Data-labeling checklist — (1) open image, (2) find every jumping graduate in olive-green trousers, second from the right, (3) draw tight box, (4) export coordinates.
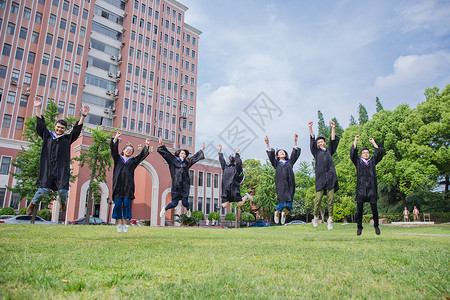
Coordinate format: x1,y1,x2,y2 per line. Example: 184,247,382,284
308,121,339,230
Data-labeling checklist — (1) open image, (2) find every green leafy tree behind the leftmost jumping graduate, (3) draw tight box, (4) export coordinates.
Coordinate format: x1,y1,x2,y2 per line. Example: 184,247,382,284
7,101,77,223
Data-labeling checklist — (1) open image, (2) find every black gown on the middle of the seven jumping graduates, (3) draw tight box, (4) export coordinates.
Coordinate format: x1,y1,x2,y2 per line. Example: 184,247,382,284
219,153,243,202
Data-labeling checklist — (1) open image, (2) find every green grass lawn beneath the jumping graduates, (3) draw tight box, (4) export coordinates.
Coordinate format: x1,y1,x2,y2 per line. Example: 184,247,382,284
0,224,450,299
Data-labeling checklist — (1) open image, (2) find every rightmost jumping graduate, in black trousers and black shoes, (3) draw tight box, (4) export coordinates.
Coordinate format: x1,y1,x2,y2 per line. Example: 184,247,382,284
350,135,383,235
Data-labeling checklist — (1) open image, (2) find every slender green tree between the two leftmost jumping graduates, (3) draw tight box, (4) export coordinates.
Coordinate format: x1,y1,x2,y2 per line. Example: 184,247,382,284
74,125,114,225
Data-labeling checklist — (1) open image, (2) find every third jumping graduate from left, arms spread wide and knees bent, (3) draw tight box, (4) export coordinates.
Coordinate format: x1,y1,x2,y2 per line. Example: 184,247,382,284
158,137,205,218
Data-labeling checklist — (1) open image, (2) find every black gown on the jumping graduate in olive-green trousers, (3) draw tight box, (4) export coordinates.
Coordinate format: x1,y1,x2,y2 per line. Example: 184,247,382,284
309,136,339,192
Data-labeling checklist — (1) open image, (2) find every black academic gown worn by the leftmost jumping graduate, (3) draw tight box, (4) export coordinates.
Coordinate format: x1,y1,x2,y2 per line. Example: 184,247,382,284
36,116,83,191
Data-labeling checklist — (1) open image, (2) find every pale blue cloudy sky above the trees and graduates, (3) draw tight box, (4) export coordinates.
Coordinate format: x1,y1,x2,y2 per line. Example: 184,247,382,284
181,0,450,160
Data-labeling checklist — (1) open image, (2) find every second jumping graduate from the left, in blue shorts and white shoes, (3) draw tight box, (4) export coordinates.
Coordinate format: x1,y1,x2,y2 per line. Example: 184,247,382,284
110,131,150,233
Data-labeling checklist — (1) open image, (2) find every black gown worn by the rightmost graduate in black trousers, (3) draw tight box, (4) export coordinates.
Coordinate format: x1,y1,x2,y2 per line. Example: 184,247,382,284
350,145,383,203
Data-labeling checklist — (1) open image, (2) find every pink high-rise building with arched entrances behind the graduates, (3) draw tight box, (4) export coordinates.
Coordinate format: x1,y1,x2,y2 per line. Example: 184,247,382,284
0,0,224,225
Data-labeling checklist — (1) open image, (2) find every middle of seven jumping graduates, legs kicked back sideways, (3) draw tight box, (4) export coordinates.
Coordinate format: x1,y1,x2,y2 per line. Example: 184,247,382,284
217,145,253,208
